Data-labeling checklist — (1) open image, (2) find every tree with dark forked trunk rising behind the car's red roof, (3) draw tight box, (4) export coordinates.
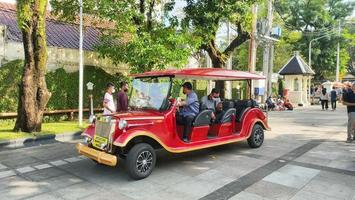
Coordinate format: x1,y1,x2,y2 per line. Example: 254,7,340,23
184,0,256,96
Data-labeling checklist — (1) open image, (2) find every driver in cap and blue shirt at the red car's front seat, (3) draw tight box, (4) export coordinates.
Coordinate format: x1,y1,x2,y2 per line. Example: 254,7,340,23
176,82,200,142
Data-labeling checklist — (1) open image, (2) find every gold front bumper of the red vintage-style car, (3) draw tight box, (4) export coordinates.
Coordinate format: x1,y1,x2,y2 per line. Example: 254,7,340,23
76,143,117,166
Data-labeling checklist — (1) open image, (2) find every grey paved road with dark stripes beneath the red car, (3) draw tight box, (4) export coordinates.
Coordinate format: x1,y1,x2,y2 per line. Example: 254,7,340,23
0,107,355,200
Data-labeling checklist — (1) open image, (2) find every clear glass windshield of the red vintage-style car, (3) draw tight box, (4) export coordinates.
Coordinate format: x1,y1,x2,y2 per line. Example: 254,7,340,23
129,77,171,110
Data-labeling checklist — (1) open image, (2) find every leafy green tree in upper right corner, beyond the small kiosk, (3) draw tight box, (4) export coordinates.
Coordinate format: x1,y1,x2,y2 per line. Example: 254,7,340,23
274,0,355,80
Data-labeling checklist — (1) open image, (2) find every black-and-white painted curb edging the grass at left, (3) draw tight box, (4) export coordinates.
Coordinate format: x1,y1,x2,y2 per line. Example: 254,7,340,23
0,131,83,151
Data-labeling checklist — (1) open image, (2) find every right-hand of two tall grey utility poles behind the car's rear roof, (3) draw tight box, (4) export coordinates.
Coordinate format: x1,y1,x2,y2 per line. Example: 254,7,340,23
263,0,273,101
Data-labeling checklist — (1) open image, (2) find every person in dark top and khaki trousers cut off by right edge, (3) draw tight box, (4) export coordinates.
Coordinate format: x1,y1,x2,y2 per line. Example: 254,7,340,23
342,82,355,143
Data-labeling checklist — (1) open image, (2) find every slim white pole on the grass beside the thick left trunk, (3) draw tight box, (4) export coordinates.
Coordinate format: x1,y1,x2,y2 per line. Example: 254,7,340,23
79,0,84,126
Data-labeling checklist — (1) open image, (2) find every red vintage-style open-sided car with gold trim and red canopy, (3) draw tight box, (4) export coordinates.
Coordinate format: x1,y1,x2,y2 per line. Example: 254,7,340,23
77,68,269,179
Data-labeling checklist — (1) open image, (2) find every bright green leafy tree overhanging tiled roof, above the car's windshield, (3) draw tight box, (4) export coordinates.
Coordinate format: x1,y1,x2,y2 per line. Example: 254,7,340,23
51,0,198,73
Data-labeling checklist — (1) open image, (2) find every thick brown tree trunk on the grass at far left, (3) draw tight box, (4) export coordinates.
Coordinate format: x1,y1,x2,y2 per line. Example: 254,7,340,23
14,0,51,132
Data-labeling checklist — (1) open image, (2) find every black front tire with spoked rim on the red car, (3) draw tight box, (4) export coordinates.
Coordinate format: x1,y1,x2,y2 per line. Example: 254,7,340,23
126,143,156,180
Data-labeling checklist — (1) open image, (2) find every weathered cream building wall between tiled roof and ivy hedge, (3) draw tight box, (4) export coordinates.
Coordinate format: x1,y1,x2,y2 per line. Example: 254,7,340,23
0,25,129,75
